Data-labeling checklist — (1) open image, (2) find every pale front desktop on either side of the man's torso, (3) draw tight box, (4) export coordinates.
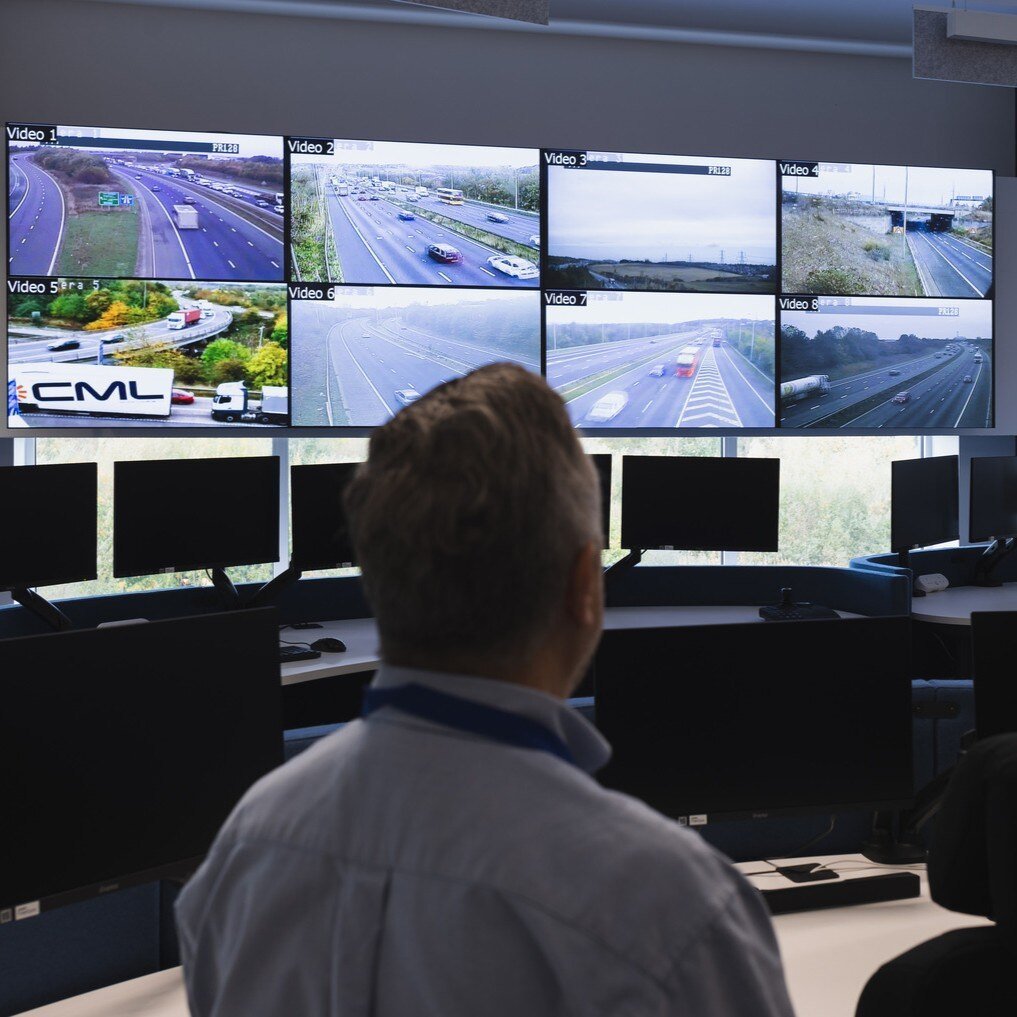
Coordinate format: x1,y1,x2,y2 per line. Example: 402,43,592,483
15,855,972,1017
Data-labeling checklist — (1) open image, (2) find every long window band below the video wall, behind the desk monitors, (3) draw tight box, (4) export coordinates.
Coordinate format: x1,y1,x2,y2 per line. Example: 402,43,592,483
15,435,959,599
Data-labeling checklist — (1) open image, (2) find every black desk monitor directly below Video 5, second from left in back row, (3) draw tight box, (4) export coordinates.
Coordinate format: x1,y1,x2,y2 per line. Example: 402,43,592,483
113,456,280,577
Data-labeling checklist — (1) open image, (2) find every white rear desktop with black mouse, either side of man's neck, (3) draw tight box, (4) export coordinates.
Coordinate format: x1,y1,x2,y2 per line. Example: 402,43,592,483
280,604,859,685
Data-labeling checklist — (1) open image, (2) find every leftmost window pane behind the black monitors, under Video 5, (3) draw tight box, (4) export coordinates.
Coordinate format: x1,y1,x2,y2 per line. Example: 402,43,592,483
28,436,273,600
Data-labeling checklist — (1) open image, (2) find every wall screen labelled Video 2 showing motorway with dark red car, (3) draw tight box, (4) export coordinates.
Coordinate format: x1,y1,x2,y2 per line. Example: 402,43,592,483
286,137,540,288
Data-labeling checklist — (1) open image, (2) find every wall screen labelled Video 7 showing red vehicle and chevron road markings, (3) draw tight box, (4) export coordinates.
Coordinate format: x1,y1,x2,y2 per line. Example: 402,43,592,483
544,290,774,429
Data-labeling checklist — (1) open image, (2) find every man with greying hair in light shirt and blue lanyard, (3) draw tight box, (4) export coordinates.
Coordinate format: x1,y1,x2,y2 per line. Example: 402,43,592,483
177,364,791,1017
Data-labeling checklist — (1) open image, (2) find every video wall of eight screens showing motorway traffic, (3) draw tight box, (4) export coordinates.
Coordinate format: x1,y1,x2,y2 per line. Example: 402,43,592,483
5,124,994,434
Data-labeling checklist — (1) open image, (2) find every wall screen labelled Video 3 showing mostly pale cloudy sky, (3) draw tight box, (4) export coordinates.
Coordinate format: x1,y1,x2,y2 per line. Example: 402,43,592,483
542,151,777,294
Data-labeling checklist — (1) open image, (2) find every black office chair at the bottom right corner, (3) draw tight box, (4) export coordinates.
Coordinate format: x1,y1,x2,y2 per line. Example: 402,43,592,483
855,734,1017,1017
